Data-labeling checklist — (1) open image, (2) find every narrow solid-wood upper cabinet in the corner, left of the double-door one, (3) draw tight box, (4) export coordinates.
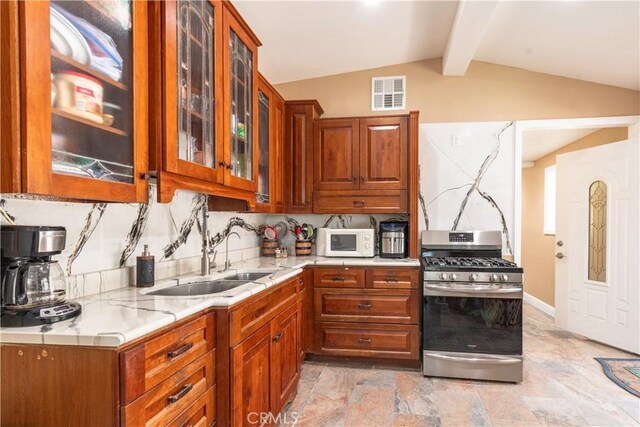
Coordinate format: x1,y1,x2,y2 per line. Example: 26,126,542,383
284,100,324,214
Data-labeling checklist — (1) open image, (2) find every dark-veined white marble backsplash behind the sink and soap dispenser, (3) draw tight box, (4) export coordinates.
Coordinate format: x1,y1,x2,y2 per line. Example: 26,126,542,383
2,186,266,297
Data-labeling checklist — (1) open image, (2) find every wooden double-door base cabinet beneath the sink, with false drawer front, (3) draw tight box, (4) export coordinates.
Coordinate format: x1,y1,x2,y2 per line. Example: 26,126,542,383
228,277,302,425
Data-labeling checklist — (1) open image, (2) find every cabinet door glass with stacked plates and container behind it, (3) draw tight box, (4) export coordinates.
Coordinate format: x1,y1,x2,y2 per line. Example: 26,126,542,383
49,0,134,183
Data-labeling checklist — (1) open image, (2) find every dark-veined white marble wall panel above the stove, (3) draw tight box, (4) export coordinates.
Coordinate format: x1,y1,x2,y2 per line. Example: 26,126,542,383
419,122,515,255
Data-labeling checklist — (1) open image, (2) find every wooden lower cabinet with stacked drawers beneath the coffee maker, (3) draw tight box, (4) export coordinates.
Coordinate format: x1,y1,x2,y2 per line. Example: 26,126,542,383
0,312,218,426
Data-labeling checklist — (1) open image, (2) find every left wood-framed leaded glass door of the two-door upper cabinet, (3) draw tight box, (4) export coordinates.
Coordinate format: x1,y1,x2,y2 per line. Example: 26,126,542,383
151,0,225,189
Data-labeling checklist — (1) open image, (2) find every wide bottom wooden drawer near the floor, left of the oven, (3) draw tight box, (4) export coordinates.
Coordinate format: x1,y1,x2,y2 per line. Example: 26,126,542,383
315,322,420,360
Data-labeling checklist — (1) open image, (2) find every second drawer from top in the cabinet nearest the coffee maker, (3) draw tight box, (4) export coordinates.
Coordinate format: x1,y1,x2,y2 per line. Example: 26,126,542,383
122,351,215,426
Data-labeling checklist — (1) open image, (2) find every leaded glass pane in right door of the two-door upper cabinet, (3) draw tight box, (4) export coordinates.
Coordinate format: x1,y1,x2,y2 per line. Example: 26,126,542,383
229,30,253,181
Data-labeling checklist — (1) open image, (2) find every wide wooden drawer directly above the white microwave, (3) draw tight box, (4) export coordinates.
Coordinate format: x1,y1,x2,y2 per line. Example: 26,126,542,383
313,190,407,214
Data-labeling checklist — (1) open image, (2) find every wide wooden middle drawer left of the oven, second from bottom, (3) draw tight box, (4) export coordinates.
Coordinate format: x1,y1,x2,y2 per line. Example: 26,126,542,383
314,288,421,324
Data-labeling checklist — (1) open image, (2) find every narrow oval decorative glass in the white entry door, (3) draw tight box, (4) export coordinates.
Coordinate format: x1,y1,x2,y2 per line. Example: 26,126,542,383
587,181,607,282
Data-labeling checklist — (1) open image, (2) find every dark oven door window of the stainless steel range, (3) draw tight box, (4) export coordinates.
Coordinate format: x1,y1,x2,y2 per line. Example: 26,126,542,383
423,296,522,354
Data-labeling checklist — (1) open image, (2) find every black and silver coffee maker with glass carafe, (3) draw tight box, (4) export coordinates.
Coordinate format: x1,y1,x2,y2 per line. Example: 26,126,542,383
0,225,82,327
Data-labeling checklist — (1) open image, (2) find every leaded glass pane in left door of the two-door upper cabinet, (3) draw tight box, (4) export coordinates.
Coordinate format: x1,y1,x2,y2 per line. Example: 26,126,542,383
177,1,216,168
